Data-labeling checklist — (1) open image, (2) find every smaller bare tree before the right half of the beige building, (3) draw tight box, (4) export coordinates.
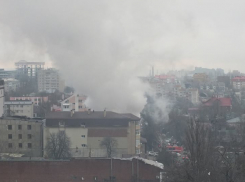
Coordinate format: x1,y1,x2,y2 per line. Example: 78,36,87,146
100,137,117,158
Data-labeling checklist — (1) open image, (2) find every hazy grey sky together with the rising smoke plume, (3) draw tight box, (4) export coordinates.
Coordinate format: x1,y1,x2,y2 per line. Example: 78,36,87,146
0,0,245,111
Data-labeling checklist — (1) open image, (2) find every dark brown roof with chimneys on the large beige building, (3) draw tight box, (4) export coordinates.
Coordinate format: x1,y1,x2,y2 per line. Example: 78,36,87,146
46,111,140,121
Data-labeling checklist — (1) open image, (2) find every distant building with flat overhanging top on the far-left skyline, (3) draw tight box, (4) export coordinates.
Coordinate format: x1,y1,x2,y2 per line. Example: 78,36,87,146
15,60,45,78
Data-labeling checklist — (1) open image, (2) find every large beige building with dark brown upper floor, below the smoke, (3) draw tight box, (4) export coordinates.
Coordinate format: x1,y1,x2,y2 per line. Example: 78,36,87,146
44,110,140,157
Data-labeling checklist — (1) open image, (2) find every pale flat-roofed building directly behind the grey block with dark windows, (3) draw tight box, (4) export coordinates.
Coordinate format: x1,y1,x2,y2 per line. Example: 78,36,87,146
4,101,34,118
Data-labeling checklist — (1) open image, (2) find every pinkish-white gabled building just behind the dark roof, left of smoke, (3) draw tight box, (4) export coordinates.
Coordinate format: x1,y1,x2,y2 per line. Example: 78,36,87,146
61,94,87,111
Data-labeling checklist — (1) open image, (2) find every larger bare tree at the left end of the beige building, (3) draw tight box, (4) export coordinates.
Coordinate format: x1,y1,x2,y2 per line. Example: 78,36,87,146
45,131,71,159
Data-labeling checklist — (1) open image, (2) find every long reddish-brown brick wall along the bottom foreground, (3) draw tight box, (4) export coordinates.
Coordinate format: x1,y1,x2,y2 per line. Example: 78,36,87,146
0,159,161,182
